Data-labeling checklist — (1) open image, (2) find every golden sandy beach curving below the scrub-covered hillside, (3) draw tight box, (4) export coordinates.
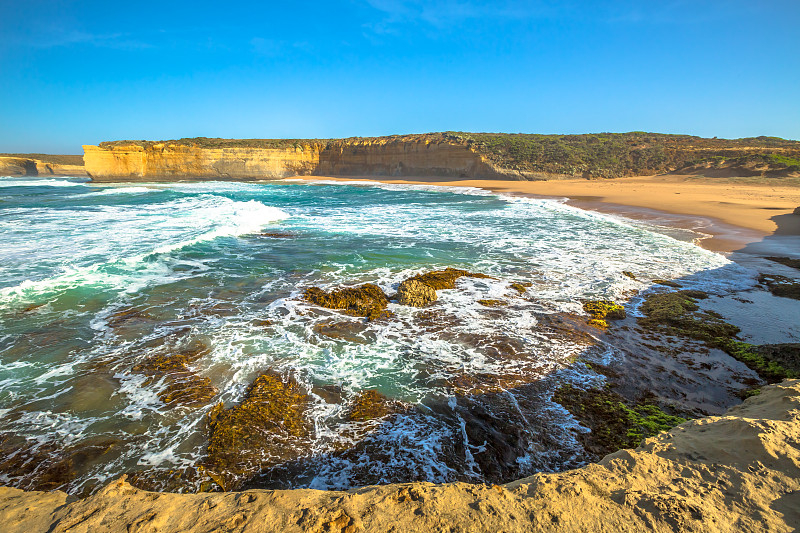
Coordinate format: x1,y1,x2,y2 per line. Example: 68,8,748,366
303,174,800,252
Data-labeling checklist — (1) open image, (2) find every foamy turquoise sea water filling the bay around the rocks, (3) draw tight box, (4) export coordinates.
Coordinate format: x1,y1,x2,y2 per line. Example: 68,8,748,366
0,178,753,492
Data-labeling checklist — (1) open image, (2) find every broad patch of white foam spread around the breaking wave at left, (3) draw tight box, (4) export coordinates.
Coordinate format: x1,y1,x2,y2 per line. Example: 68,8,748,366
0,195,289,301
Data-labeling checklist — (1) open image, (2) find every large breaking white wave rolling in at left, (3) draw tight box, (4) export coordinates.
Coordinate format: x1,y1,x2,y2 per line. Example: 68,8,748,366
0,195,289,301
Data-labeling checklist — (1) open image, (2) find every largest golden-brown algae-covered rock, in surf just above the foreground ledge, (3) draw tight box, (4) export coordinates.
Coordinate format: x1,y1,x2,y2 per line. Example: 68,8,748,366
203,372,313,490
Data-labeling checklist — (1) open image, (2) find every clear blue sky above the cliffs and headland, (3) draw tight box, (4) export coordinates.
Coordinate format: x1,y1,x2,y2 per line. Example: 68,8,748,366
0,0,800,153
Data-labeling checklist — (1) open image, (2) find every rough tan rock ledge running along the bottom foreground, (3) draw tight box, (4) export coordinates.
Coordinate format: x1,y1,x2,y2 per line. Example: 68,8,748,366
0,380,800,533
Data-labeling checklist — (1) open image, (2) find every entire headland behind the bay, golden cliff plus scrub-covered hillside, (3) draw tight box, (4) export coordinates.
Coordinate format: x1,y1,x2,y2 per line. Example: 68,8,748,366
84,132,800,180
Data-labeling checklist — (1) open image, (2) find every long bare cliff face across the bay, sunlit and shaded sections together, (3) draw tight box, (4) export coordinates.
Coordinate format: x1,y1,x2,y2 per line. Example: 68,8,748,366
83,137,552,181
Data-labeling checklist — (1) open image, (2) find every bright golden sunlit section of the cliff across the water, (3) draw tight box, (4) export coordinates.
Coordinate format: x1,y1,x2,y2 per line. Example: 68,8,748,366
83,143,319,181
